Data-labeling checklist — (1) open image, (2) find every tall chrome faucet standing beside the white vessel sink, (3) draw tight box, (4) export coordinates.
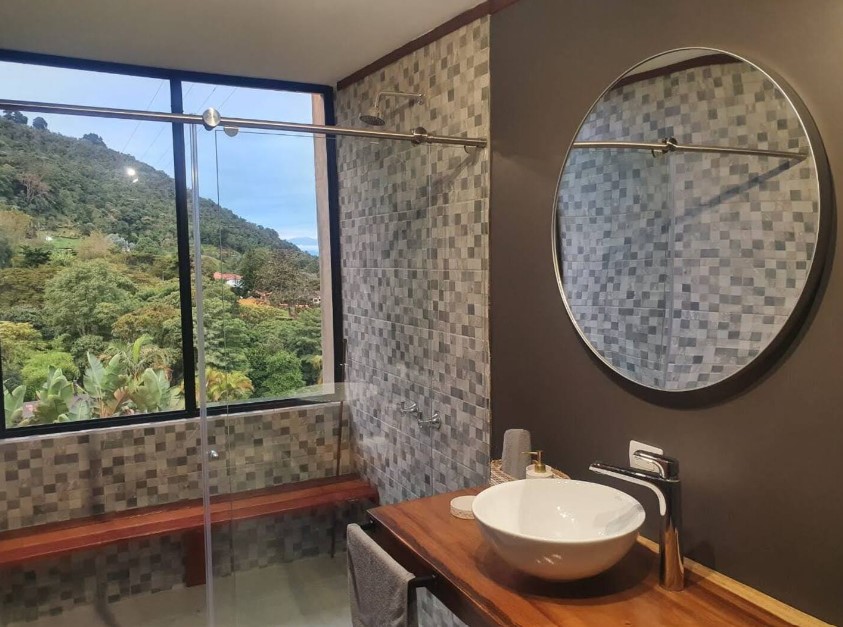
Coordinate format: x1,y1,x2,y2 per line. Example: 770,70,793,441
588,451,685,591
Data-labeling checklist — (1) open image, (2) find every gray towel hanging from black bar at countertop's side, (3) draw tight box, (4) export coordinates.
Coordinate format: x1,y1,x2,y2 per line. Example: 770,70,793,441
346,524,418,627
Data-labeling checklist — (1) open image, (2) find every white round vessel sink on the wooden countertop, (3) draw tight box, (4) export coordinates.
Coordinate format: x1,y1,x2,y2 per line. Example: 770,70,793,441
472,479,644,581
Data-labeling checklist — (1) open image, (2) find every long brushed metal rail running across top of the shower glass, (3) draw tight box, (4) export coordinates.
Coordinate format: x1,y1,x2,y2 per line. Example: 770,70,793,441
0,100,487,148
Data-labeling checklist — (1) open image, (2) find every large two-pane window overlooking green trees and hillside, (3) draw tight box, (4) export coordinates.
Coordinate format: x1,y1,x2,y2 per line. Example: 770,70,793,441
0,56,335,435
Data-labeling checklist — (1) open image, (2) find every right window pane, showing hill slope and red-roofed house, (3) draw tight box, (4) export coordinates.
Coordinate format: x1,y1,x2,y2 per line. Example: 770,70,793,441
186,86,328,405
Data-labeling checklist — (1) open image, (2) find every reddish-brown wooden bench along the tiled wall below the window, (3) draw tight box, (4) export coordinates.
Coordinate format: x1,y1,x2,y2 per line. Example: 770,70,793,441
0,475,379,586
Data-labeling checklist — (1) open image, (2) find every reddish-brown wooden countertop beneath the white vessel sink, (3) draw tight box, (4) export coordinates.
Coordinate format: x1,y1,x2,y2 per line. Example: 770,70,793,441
369,489,823,627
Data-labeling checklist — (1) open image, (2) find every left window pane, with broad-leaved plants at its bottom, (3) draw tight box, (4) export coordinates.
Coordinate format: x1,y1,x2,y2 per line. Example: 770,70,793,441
0,64,184,428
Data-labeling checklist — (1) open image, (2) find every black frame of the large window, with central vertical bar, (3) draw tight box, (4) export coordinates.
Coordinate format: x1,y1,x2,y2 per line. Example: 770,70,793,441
0,49,345,441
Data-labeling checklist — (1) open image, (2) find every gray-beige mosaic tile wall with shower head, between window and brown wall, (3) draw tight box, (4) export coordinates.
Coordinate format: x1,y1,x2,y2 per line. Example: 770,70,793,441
337,18,489,625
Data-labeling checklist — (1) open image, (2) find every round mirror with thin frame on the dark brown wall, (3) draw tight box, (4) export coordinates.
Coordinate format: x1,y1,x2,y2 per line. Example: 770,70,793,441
554,48,829,392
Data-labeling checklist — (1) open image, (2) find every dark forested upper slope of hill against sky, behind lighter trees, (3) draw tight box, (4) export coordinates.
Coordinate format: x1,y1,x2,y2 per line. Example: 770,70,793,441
0,114,313,263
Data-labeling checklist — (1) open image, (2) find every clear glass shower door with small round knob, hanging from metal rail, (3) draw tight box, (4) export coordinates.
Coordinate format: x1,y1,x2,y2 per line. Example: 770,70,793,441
190,124,468,626
